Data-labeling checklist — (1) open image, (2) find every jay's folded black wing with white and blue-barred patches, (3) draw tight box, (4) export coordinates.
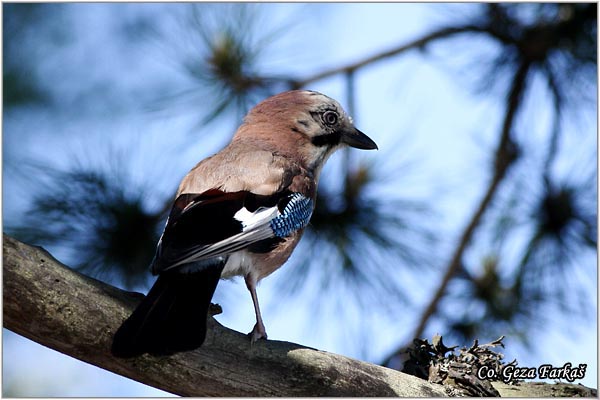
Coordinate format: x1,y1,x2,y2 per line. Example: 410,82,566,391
152,189,314,274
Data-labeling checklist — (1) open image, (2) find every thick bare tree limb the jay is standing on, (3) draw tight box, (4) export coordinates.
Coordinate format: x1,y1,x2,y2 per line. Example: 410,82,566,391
3,235,446,397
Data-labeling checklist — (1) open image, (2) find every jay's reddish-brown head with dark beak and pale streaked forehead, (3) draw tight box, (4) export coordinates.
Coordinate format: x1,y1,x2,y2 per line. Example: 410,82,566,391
234,90,377,170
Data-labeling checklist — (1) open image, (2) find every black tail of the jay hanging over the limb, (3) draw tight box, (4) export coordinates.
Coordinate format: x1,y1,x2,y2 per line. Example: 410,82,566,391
111,266,222,357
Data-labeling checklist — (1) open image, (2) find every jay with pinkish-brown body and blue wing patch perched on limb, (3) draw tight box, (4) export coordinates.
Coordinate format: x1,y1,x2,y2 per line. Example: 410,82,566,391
111,90,378,358
